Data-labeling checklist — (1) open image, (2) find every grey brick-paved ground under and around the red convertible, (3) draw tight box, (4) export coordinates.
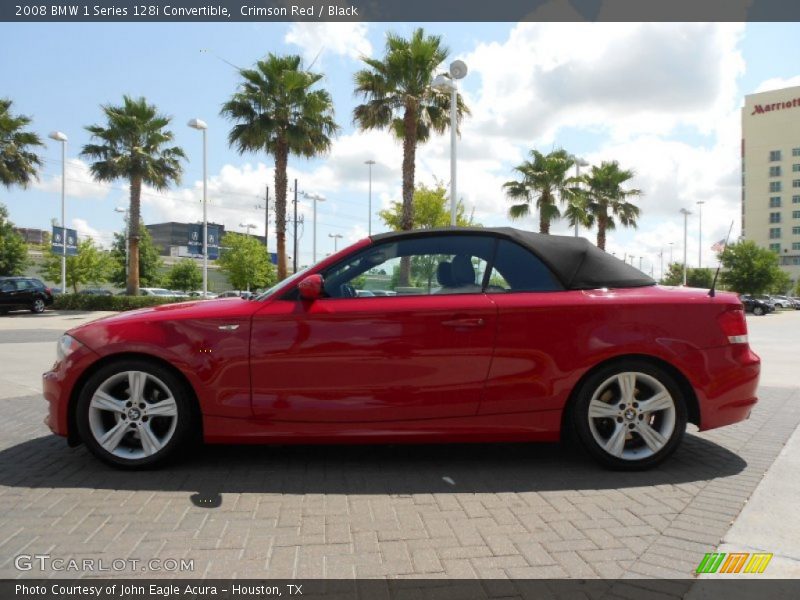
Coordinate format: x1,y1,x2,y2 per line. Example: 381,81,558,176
0,313,800,578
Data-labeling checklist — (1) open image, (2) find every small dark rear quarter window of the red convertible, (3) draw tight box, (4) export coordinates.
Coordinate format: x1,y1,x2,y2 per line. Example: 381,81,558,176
486,240,564,293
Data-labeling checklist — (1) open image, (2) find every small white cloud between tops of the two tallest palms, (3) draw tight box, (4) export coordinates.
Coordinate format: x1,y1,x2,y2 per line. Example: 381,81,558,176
284,22,372,69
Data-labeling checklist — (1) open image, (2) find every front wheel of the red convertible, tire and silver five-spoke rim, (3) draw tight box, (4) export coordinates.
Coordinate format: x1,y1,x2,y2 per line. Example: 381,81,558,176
77,359,194,469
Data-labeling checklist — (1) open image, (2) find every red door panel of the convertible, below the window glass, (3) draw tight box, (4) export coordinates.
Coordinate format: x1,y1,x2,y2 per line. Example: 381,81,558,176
251,293,497,422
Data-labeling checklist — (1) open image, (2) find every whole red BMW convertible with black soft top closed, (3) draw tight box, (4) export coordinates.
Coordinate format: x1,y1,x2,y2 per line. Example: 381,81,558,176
44,228,760,469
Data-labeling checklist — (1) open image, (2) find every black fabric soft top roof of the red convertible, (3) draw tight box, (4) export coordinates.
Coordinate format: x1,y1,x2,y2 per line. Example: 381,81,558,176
372,227,656,290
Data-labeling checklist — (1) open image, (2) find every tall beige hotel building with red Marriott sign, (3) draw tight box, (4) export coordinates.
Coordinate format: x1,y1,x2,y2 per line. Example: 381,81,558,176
742,86,800,281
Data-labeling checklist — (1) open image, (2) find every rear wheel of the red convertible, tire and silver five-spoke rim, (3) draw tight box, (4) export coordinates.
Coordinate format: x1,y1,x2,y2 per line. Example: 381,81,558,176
571,360,688,471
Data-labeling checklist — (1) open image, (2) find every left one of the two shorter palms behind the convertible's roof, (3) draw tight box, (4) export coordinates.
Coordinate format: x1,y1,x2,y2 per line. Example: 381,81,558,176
503,150,582,234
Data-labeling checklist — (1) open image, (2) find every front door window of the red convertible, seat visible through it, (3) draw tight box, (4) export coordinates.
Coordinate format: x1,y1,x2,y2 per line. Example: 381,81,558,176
323,235,494,298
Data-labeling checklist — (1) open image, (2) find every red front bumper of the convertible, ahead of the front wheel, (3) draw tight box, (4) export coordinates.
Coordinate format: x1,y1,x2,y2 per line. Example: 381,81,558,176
42,345,100,436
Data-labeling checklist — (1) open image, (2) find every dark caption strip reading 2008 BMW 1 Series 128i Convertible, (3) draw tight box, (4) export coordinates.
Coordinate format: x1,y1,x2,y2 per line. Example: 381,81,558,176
0,0,800,22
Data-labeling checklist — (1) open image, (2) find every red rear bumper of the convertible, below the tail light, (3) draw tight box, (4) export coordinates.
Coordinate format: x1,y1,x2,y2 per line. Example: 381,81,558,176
694,344,761,431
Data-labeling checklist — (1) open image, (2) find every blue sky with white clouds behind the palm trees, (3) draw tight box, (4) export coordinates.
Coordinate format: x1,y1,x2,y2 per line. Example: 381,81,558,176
0,23,800,275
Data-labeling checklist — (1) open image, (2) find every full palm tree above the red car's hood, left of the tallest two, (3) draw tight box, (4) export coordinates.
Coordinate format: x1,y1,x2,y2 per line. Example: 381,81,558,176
81,96,186,296
